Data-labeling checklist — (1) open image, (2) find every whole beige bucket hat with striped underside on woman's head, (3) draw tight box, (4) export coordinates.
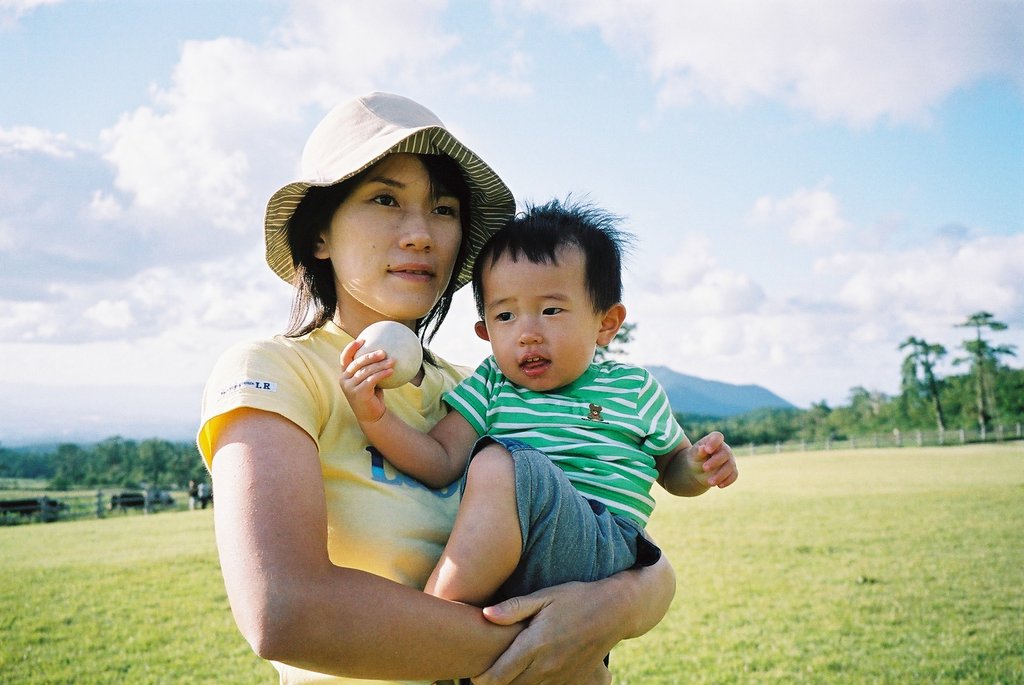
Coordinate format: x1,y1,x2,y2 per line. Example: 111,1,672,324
264,92,515,288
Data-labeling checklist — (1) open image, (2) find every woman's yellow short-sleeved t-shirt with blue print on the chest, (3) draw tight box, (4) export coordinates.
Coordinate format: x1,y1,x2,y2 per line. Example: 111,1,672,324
198,324,469,685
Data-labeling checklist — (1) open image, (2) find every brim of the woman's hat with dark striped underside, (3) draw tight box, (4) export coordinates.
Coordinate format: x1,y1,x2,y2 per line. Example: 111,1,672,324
264,126,515,289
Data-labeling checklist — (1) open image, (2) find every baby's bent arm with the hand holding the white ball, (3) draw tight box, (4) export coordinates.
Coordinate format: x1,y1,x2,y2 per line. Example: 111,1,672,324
340,341,477,487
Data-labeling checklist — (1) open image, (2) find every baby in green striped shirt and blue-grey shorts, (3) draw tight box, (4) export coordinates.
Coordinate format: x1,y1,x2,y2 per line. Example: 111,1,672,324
341,196,737,605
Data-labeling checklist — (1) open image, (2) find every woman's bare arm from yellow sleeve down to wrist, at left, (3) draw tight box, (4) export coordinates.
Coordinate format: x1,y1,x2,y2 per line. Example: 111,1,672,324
213,410,512,680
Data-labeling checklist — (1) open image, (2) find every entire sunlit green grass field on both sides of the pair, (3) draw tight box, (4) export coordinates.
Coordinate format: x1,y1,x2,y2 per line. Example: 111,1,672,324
0,443,1024,685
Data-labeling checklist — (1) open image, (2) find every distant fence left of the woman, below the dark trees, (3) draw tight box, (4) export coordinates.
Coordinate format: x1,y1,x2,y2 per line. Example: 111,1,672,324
0,488,185,525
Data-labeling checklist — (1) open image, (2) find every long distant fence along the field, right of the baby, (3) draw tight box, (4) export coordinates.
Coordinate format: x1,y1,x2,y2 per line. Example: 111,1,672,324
745,423,1024,455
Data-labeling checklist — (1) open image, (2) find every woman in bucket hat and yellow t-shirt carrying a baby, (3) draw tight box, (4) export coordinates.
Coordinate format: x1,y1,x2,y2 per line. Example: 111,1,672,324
199,93,675,683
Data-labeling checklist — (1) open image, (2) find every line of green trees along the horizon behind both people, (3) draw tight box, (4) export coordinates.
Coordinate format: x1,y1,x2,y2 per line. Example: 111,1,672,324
0,311,1024,489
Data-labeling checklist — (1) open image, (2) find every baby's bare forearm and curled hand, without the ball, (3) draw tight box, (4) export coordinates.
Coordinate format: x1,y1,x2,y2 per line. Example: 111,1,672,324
656,431,739,497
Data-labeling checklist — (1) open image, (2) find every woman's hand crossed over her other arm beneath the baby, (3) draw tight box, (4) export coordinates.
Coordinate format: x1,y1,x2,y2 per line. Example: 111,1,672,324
473,581,623,685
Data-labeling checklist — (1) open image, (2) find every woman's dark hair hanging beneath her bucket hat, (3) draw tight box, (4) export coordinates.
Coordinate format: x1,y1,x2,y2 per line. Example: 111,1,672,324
285,150,471,343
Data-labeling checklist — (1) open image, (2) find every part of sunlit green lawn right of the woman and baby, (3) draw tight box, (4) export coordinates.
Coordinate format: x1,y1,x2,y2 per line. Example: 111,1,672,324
613,443,1024,685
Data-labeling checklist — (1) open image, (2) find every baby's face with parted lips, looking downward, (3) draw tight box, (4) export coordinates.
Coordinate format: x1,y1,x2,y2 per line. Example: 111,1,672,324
477,247,603,392
